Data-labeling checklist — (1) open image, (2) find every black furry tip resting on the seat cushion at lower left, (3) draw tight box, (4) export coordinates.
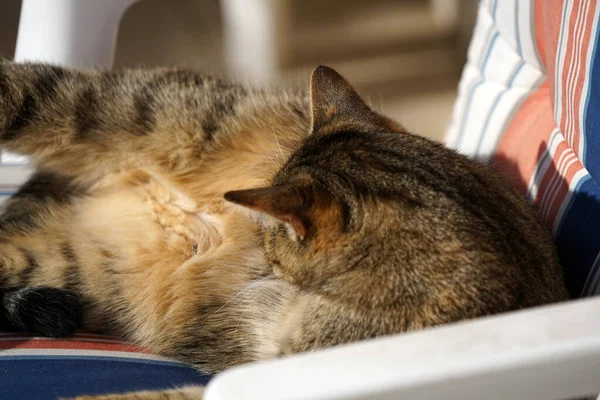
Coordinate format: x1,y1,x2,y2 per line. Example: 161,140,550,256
0,286,83,337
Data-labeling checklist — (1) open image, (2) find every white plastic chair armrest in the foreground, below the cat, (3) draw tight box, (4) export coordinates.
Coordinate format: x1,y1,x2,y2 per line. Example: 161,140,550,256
205,298,600,400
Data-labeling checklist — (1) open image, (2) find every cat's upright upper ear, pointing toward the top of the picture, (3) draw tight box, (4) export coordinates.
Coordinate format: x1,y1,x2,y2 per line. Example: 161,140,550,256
310,65,404,133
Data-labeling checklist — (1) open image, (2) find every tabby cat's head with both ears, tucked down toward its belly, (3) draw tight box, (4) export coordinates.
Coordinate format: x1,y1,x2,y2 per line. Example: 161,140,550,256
225,67,418,308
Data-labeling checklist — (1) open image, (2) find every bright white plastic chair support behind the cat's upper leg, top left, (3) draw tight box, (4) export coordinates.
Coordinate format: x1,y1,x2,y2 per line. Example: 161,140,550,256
0,0,137,199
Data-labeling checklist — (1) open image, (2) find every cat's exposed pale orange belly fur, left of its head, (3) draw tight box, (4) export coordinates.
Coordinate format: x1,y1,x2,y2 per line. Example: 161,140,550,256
72,175,266,354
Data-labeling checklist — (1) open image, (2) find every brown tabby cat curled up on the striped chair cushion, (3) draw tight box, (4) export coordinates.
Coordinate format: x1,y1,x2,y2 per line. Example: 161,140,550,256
0,61,567,399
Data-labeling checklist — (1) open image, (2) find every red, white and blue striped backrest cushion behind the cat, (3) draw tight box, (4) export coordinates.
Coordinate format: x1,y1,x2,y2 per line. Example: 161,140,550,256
446,0,600,297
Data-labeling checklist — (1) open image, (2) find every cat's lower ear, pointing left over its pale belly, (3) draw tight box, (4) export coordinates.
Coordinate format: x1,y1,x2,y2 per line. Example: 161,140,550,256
225,184,314,240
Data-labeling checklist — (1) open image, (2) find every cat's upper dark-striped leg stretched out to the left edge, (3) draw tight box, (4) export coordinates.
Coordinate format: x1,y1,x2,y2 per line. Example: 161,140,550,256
0,61,246,183
